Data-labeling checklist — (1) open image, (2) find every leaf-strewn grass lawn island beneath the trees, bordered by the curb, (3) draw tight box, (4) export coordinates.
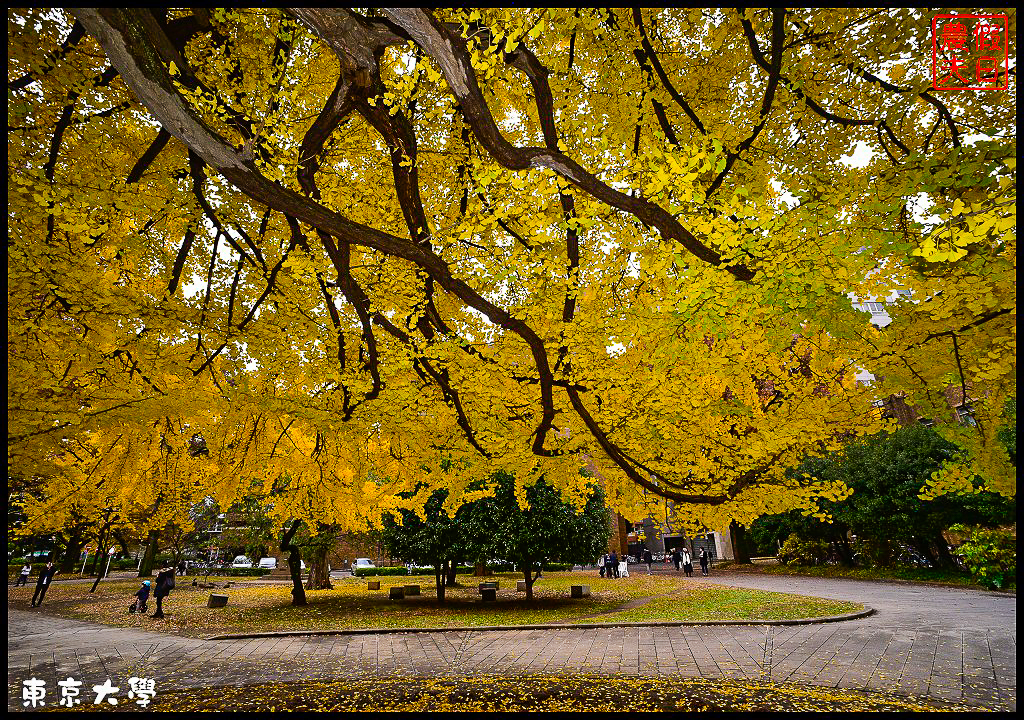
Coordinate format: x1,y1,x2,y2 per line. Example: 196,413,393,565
8,573,862,636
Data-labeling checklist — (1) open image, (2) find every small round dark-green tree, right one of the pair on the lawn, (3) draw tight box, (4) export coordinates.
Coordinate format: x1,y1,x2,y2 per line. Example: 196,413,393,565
460,472,610,600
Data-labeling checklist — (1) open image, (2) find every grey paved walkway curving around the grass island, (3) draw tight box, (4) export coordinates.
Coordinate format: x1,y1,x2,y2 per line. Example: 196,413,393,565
7,573,1017,710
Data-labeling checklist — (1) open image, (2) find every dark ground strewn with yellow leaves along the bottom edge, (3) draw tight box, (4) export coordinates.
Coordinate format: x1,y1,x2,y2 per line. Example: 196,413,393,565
58,675,976,712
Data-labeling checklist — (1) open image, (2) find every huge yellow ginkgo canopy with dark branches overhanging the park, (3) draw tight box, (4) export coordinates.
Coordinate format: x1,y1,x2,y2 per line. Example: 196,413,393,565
8,8,1016,544
